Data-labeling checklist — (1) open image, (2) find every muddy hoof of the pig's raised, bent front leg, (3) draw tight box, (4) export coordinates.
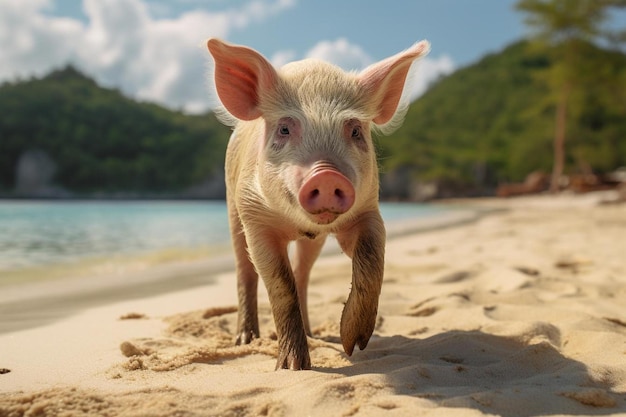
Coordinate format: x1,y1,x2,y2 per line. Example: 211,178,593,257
340,297,377,356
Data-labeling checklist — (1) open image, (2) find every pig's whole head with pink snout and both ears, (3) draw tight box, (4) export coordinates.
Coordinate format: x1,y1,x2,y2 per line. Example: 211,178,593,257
208,39,429,231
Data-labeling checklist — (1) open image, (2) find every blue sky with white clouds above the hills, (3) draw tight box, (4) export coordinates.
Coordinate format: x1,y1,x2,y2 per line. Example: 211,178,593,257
0,0,568,113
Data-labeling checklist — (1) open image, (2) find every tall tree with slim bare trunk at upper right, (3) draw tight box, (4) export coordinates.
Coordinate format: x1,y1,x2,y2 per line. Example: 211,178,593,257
516,0,626,192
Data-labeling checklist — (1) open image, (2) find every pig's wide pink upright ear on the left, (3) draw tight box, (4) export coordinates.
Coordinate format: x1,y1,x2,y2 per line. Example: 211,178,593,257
207,39,278,120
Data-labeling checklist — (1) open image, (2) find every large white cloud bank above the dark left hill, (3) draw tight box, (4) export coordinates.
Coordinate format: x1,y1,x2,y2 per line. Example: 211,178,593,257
0,0,294,111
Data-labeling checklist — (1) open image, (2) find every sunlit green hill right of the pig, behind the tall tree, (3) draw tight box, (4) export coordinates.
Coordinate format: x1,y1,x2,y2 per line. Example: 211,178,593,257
378,42,626,198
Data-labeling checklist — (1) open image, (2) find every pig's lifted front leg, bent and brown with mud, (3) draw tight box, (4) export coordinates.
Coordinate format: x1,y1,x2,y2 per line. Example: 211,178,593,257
337,211,385,355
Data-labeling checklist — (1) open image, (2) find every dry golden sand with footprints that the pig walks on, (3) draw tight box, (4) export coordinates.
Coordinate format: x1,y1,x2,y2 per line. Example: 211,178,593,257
0,194,626,417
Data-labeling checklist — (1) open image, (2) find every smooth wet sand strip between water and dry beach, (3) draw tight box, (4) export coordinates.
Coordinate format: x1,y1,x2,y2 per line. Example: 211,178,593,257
0,204,478,335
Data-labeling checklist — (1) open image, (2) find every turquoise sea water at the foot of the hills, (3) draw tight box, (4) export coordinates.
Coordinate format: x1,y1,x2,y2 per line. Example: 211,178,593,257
0,201,445,274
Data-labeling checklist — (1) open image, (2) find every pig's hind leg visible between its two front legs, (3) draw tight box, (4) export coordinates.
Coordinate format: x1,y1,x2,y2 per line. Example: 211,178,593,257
292,236,326,336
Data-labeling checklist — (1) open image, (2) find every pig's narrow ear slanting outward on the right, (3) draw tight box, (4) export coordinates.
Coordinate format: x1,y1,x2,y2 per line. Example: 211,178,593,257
359,41,430,131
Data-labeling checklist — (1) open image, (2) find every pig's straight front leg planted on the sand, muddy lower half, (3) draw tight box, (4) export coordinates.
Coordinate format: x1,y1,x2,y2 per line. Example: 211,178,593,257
246,230,311,370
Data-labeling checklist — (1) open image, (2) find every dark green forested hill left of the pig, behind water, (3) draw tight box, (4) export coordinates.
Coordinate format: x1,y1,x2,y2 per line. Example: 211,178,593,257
0,67,229,197
